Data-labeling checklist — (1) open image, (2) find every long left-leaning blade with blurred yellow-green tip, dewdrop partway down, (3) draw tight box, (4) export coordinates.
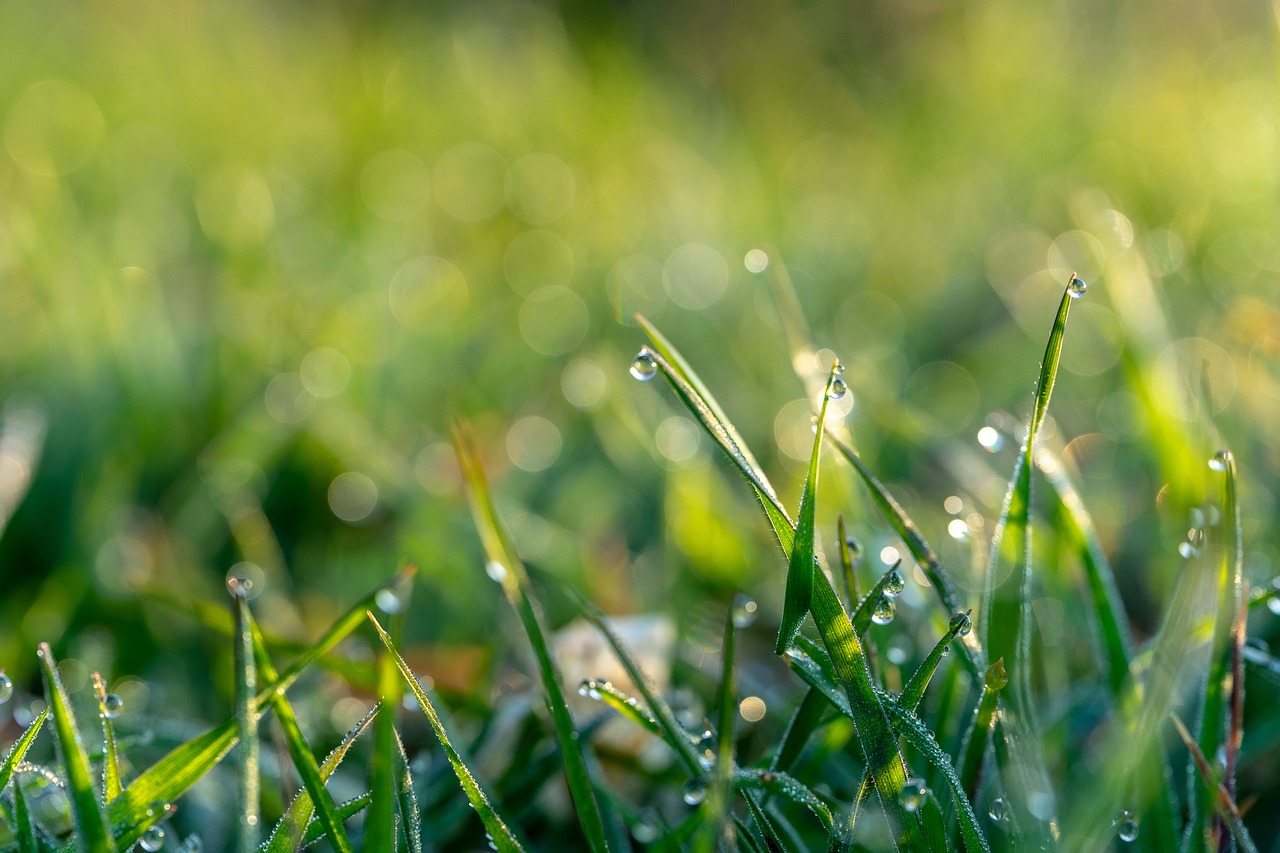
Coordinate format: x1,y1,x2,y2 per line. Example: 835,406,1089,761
453,424,609,852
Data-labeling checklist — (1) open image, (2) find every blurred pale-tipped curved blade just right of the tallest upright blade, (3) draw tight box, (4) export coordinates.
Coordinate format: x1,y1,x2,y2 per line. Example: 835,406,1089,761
1036,448,1133,697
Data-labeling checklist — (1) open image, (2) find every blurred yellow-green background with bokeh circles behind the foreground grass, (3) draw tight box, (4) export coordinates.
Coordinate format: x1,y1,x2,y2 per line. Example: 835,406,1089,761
0,0,1280,833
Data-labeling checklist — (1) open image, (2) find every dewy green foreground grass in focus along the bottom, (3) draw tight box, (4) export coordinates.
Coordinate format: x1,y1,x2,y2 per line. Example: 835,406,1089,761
0,262,1280,853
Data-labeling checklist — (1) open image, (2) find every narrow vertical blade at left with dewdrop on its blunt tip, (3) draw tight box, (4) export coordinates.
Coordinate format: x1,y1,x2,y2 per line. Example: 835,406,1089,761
227,578,261,853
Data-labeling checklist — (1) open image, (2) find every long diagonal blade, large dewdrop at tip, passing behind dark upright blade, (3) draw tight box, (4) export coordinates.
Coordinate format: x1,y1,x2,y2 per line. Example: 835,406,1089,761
637,322,923,848
